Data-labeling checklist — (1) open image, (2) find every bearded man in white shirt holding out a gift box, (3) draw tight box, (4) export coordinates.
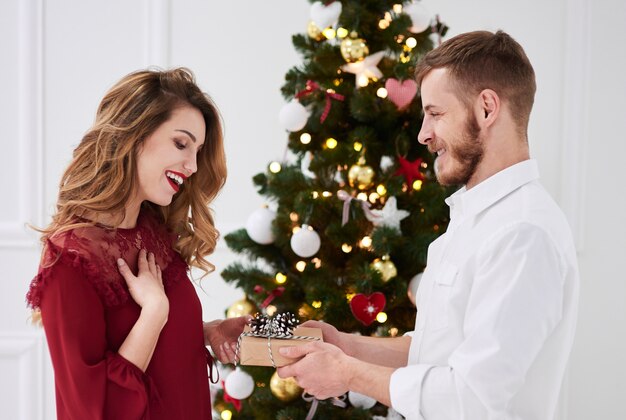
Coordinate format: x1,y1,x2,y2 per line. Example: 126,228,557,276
278,31,578,420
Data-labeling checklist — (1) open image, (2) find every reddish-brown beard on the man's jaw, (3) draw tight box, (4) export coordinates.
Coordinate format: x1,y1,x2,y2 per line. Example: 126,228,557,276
435,113,484,185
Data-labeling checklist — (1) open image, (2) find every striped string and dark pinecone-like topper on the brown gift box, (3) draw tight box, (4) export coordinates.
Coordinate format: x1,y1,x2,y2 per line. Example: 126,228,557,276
234,312,319,368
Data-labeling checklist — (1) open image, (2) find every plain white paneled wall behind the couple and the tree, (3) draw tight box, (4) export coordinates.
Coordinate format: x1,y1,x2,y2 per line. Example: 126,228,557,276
0,0,626,420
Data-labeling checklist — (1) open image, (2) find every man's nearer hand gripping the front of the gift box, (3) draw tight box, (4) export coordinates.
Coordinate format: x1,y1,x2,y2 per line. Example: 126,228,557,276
278,340,355,400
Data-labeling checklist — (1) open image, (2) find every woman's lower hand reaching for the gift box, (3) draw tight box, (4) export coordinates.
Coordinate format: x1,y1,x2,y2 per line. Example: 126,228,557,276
204,315,247,363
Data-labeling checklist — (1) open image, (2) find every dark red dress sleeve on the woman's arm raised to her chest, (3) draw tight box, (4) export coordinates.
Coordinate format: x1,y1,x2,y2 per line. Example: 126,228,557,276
38,251,158,419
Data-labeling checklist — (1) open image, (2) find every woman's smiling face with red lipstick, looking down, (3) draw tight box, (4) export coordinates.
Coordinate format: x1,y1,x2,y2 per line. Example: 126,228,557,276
135,105,206,206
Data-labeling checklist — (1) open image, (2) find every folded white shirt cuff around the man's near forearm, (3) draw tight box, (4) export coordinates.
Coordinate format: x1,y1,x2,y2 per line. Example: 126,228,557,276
389,365,433,420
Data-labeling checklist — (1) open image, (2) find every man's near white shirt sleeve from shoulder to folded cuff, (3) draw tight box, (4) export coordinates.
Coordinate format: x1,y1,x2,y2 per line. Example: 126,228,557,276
389,223,564,420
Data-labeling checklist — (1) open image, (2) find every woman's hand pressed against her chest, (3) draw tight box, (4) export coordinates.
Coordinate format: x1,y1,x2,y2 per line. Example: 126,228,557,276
117,249,169,318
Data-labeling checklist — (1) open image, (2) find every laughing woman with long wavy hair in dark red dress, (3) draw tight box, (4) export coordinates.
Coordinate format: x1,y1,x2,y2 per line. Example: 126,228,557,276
27,69,246,419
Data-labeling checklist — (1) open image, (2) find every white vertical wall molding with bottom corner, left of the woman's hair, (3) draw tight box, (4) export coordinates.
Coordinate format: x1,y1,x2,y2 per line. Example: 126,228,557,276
0,0,43,248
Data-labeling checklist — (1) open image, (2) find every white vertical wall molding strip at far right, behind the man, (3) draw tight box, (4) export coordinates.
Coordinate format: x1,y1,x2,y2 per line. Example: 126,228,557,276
561,0,591,253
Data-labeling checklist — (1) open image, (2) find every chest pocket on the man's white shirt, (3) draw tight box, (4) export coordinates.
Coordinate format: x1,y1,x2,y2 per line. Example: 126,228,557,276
427,261,459,330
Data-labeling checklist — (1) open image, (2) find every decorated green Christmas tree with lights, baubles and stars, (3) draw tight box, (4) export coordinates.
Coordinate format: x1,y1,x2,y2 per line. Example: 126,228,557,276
215,0,450,419
